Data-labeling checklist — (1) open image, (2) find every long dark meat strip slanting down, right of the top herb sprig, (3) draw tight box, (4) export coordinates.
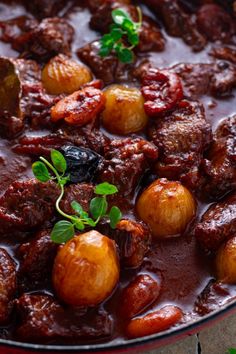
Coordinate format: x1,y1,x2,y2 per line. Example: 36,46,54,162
144,0,206,52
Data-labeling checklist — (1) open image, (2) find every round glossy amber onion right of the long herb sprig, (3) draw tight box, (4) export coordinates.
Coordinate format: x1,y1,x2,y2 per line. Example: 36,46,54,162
136,178,196,238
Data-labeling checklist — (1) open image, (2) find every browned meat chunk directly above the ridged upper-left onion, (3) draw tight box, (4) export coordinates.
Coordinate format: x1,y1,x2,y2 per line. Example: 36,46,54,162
0,16,74,61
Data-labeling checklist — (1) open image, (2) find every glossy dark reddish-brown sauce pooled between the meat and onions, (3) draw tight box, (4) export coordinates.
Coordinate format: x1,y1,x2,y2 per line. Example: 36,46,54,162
0,2,236,341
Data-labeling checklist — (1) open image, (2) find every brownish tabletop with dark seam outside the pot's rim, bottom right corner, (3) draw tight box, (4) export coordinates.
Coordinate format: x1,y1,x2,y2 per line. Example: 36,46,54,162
145,315,236,354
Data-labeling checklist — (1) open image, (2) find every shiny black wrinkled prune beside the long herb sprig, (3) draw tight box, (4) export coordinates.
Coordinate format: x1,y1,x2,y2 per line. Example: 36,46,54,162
61,145,102,183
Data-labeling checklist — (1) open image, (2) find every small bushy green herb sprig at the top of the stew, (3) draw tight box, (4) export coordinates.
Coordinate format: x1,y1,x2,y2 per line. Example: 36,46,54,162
99,7,142,63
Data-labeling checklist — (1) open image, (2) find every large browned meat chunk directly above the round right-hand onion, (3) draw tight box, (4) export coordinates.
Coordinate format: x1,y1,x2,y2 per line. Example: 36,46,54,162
149,100,212,189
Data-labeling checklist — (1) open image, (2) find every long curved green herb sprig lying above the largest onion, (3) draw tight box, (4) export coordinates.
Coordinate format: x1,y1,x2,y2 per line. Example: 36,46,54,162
32,150,122,243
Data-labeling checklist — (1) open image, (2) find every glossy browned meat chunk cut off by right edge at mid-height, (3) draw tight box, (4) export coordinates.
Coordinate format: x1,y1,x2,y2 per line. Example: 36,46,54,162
202,115,236,198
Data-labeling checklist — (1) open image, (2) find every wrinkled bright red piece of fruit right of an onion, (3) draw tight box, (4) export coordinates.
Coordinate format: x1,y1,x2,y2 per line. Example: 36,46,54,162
142,68,183,116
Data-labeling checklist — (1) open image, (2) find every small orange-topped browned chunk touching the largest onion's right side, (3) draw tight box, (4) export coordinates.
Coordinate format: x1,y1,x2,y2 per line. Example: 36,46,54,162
112,219,151,268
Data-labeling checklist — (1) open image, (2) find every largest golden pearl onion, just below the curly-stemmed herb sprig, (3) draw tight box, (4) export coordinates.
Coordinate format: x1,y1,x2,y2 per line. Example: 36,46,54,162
53,231,120,307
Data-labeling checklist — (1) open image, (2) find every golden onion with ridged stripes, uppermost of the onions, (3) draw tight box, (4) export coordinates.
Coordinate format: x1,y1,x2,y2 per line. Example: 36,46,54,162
42,54,92,95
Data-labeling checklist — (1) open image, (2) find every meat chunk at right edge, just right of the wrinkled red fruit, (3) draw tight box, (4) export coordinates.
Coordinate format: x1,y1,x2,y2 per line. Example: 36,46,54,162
171,61,236,99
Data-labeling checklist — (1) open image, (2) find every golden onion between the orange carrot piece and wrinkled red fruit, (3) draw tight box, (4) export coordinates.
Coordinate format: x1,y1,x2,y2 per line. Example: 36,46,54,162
102,85,148,135
